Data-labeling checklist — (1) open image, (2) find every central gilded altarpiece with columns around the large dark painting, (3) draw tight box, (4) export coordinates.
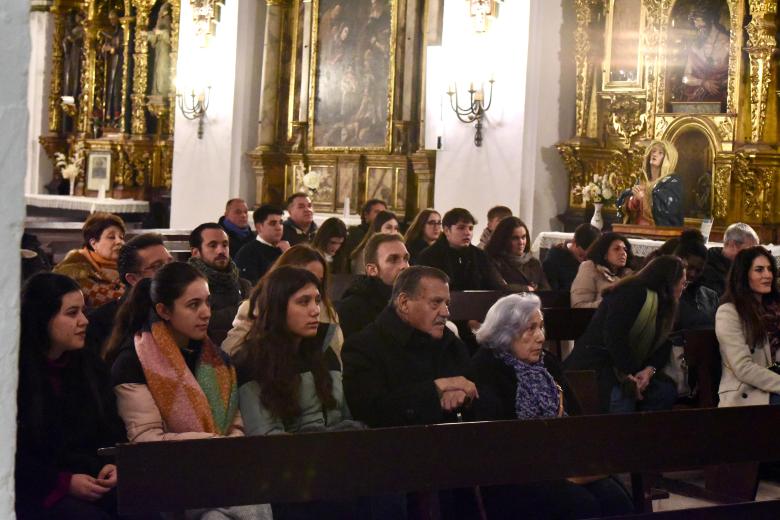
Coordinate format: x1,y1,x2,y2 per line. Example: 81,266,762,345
249,0,435,218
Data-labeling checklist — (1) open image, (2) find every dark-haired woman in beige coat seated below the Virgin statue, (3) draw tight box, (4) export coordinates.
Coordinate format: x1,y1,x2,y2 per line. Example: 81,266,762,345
571,233,634,308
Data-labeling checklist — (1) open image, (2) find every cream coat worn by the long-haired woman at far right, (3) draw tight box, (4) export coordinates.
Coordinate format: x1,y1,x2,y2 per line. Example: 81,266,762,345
715,303,780,406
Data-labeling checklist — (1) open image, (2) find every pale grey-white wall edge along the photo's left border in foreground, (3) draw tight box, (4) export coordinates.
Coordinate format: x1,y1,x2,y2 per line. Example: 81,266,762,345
0,0,30,518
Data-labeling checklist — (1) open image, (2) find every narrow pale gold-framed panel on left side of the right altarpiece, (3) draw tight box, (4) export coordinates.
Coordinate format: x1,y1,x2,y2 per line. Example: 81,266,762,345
604,0,643,90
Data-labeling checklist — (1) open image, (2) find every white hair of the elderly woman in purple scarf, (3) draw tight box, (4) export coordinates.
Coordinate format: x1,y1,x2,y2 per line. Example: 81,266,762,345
477,293,542,350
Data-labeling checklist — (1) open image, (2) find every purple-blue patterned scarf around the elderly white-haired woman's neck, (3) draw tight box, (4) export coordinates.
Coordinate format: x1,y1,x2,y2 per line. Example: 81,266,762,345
493,349,566,419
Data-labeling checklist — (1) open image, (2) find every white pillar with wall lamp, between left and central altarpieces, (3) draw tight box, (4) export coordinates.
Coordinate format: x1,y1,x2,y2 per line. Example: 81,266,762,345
171,0,264,228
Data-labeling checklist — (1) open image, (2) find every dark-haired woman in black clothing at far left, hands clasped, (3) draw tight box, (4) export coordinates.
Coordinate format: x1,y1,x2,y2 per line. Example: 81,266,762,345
16,273,125,519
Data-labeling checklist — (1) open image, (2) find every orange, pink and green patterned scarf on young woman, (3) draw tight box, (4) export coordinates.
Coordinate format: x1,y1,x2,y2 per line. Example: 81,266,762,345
135,321,238,435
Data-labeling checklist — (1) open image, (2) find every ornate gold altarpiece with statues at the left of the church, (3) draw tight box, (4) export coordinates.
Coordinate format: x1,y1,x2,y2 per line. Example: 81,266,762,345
40,0,180,207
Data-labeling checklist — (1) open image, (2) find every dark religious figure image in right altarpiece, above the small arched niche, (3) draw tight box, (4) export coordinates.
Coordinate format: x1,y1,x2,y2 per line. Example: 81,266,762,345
667,0,731,114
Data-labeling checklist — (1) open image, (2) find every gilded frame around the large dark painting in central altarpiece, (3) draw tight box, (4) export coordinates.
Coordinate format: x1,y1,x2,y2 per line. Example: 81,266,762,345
308,0,398,152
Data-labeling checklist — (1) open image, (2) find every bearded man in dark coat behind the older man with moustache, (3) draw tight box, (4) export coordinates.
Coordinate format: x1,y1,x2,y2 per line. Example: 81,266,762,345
336,233,409,340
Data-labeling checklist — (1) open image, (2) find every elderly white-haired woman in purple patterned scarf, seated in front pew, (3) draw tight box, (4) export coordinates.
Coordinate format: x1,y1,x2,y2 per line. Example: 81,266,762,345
469,294,633,518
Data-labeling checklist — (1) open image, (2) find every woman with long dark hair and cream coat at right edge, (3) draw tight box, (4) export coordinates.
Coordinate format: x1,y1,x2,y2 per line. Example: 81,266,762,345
715,246,780,406
